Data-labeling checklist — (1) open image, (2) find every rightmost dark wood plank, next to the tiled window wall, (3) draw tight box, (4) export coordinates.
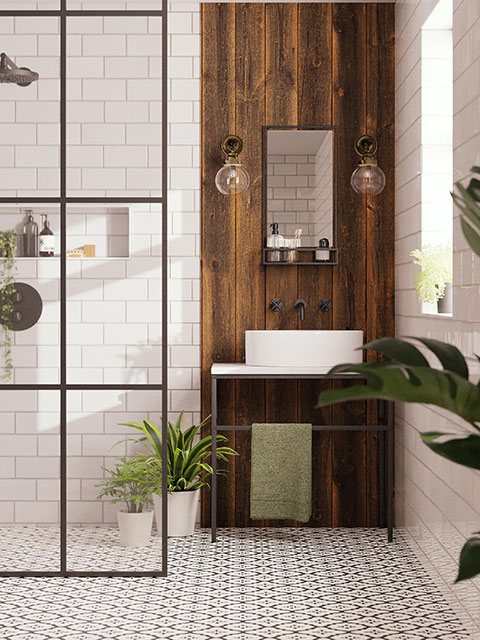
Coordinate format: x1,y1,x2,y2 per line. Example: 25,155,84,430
366,3,395,526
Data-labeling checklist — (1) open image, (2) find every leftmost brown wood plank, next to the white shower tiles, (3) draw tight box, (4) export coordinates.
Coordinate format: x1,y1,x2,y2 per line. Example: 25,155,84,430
201,4,237,526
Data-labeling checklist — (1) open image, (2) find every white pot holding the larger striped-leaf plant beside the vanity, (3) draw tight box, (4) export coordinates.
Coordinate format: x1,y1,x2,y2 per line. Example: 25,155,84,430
153,489,200,538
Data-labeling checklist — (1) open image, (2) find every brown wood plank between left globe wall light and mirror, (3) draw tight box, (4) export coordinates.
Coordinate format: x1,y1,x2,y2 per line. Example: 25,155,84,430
235,4,265,527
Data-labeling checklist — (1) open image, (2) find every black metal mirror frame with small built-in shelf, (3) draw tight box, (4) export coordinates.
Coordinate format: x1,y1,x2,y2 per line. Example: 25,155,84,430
262,124,338,267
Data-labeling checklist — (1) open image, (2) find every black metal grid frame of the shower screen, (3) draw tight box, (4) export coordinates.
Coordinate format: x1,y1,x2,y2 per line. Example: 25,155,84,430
0,0,168,578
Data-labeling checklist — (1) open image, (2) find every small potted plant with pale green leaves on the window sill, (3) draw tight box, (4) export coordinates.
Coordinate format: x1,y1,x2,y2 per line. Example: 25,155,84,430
410,244,453,313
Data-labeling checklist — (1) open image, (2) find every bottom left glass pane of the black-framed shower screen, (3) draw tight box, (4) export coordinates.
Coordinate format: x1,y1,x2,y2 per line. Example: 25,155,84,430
0,390,59,573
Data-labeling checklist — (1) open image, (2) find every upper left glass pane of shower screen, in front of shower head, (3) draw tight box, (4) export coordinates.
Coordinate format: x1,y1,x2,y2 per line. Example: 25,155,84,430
0,16,60,197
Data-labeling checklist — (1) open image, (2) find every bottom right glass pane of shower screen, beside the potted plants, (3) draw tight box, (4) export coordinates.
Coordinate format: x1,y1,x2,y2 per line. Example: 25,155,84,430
67,390,162,572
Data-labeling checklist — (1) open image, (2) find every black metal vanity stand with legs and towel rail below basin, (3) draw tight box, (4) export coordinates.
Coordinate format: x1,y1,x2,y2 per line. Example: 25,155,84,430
211,365,394,542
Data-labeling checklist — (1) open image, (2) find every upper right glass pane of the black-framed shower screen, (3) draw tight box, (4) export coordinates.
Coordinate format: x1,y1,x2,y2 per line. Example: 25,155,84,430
67,17,162,198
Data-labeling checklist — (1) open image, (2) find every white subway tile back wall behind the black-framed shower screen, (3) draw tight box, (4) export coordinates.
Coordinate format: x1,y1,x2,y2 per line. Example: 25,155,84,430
0,2,200,524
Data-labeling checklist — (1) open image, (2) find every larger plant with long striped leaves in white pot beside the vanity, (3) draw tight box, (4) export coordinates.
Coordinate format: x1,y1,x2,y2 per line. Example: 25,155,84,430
122,411,238,537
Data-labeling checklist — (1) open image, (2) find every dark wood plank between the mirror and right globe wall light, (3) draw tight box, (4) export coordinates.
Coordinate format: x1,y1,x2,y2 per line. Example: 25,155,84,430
332,4,367,527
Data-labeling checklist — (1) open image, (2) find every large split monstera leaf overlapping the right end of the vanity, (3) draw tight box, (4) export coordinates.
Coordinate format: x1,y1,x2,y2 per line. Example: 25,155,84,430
317,338,480,430
